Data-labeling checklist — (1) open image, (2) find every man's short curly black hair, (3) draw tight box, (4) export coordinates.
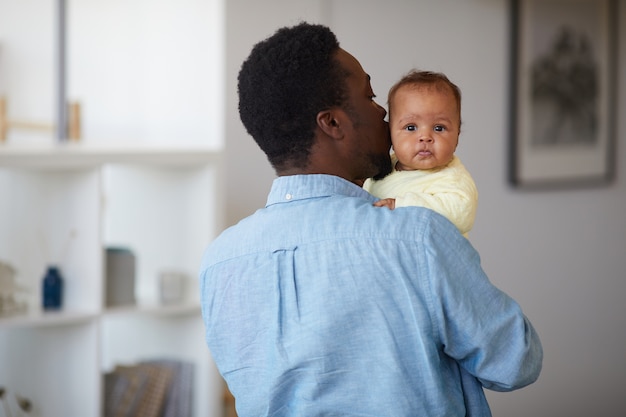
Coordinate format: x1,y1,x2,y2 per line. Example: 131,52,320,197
238,22,347,172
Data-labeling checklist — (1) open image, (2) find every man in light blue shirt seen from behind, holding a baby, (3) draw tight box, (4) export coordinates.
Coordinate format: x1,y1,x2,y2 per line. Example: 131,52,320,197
200,23,542,417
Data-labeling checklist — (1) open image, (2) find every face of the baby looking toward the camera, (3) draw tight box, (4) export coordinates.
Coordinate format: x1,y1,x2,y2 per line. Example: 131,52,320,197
389,85,461,171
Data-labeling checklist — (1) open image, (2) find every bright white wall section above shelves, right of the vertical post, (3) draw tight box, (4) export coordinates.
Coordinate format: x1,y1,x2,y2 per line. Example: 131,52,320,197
67,0,224,148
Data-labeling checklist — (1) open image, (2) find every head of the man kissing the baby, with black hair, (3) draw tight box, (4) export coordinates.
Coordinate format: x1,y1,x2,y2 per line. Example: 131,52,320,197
238,23,391,181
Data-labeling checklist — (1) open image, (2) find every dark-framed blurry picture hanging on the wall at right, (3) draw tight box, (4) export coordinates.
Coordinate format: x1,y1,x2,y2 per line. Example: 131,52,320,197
509,0,617,188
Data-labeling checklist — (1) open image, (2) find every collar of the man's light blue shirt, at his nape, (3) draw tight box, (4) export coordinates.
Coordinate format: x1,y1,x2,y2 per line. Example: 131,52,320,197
266,174,377,207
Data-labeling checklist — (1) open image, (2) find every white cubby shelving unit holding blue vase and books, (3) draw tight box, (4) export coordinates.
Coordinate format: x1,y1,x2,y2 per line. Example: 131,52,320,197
0,143,222,417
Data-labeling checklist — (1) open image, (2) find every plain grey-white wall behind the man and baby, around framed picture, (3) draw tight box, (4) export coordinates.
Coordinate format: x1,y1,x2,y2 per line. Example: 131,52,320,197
225,0,626,417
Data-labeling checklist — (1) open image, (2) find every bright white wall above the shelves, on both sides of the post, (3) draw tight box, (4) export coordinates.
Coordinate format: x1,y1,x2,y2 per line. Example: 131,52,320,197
0,0,224,149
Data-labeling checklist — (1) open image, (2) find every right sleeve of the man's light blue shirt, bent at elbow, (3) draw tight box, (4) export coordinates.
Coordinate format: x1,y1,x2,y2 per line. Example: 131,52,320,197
427,214,543,391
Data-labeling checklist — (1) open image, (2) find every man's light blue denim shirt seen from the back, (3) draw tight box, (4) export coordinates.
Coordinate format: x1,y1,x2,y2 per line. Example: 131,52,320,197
200,175,543,417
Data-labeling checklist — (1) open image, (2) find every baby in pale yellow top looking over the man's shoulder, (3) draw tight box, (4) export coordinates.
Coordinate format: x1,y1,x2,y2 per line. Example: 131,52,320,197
363,71,478,237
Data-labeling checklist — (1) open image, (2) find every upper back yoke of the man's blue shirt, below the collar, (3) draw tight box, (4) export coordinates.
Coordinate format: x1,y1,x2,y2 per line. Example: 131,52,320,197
205,196,456,262
